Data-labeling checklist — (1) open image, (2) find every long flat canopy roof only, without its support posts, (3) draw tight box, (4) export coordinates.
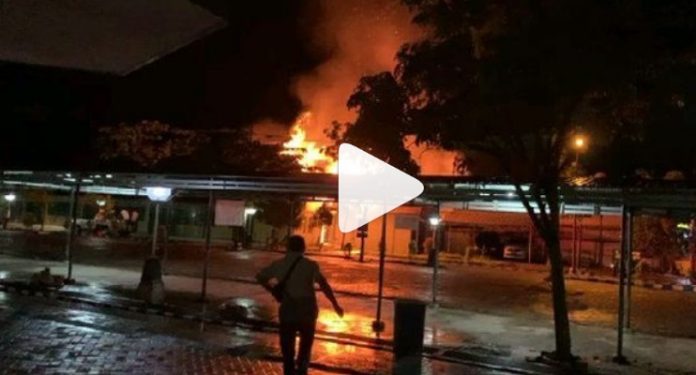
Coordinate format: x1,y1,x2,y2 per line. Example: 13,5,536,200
2,171,696,215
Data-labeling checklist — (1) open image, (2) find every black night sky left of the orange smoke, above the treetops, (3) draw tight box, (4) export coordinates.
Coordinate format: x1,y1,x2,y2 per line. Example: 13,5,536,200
0,0,331,169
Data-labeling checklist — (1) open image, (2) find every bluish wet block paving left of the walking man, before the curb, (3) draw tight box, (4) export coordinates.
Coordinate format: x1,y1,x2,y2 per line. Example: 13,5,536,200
0,295,281,374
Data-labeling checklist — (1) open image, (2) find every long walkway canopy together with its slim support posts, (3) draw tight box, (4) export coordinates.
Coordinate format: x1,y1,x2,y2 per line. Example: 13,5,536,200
0,171,696,358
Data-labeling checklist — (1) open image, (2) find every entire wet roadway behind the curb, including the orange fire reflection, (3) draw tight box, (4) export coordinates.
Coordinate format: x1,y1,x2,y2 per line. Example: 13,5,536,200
0,251,696,373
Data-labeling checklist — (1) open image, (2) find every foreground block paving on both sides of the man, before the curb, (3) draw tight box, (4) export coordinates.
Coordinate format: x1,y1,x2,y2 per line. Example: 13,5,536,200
0,292,506,375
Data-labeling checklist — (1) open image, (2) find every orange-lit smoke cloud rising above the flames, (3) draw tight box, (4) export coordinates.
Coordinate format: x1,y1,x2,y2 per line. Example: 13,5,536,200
294,0,419,141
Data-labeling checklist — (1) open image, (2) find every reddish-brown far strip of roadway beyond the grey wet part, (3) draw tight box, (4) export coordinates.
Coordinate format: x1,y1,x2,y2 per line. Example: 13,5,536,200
134,247,696,338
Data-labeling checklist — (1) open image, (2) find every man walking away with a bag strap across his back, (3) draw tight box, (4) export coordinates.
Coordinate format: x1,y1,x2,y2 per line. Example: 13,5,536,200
256,236,343,375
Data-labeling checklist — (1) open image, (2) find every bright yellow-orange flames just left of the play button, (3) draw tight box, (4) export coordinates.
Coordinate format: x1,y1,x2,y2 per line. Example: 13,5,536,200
282,112,337,174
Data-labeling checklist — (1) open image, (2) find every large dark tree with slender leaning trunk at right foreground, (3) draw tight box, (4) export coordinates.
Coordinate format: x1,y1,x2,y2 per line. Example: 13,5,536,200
346,0,696,361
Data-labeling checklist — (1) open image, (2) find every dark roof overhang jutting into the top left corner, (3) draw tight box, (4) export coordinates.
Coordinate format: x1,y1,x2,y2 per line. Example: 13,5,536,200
0,0,225,75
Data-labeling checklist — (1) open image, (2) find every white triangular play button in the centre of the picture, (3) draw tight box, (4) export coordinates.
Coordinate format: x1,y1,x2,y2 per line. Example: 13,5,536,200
338,143,423,233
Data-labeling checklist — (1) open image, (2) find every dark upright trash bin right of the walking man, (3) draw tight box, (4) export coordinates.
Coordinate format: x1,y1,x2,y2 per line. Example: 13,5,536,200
393,299,425,359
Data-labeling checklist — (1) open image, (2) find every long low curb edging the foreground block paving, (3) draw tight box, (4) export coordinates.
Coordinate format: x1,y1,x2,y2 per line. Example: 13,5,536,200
0,281,549,375
